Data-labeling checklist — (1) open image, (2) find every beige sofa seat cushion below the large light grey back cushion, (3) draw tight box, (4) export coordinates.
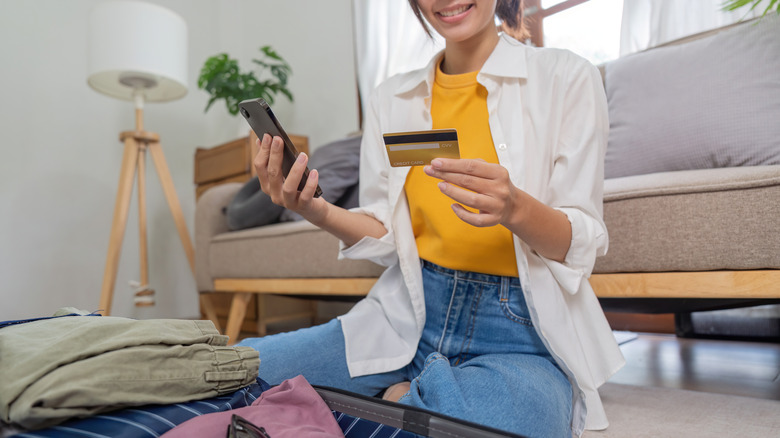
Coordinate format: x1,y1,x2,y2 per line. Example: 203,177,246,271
593,166,780,273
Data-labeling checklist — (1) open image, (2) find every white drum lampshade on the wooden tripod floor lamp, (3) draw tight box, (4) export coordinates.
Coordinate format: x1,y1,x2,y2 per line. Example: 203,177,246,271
87,1,187,102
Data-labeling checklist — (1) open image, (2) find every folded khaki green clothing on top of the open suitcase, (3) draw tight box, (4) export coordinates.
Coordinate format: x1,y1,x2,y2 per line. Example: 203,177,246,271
0,316,260,429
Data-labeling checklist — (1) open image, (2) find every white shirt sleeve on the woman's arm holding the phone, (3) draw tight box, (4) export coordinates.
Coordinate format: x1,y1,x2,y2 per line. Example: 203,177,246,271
339,86,398,266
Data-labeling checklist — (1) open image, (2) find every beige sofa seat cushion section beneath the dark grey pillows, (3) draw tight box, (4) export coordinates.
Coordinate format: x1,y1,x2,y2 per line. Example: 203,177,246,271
208,221,384,278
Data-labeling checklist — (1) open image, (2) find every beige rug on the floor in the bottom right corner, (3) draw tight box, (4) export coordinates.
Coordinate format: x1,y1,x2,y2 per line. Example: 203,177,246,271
583,383,780,438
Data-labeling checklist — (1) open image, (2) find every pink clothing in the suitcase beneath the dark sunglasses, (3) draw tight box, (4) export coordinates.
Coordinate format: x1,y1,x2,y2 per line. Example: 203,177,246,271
163,376,344,438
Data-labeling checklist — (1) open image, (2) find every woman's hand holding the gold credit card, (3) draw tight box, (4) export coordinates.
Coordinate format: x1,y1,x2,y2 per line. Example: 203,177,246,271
423,158,521,227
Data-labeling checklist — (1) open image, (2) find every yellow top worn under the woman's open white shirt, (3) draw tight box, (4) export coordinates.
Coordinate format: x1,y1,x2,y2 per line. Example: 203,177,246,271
404,62,517,276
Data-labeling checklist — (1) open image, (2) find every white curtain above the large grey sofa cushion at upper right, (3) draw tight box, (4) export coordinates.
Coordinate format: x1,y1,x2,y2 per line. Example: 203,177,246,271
620,0,764,56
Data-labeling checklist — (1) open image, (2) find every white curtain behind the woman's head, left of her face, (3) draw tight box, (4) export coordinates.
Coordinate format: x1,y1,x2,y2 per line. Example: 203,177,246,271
352,0,444,121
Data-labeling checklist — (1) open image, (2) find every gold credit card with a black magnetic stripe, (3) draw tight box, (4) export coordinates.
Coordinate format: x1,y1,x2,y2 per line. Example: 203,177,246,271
383,129,460,167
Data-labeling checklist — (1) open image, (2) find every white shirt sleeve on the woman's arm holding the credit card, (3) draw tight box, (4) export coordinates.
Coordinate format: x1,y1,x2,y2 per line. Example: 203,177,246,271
542,60,609,294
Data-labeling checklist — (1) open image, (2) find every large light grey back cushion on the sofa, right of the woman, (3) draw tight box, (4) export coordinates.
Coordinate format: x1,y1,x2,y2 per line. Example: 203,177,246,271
605,14,780,178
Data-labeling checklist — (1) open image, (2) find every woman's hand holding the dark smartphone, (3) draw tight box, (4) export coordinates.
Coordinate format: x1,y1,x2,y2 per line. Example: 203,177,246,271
253,134,328,224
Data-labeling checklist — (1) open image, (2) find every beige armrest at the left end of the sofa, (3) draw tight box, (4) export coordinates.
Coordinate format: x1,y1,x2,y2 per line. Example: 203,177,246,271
195,183,243,292
